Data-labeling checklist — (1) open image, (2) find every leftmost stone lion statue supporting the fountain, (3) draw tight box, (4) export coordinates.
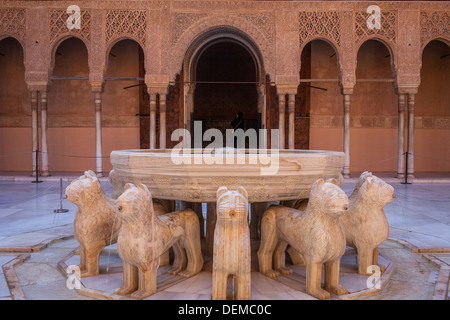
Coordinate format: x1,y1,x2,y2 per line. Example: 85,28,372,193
66,170,121,277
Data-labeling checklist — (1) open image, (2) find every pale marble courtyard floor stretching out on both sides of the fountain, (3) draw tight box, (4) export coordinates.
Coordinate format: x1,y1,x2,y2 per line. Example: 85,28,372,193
0,175,450,300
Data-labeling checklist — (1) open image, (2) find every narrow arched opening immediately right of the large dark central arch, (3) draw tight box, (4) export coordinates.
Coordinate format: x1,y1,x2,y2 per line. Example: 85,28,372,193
304,39,343,151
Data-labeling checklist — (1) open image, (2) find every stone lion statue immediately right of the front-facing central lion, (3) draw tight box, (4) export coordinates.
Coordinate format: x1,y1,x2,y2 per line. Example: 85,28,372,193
258,179,348,299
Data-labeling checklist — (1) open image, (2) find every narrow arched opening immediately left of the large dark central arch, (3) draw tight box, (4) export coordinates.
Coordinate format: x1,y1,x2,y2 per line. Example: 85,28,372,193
102,38,142,171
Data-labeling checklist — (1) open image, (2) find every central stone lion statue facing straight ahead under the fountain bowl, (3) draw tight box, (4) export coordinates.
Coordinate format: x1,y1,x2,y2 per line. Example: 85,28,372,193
212,186,251,300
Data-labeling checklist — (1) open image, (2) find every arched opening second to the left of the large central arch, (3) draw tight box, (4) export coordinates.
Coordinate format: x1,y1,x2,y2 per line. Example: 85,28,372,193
47,37,95,172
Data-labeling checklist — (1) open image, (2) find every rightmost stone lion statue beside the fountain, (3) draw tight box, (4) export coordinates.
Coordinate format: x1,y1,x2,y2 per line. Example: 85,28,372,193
341,171,394,275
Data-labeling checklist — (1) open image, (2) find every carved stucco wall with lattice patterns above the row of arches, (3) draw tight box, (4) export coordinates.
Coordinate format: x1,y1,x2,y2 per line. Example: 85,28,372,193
0,1,450,90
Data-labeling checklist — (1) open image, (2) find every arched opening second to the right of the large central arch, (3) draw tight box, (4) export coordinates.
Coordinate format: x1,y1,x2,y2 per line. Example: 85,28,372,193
350,39,398,172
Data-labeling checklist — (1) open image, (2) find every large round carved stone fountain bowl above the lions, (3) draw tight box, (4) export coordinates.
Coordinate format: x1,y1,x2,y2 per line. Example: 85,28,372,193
111,148,345,202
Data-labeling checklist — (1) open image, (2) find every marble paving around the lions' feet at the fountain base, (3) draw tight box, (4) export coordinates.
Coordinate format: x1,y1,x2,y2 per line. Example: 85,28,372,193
59,249,395,300
